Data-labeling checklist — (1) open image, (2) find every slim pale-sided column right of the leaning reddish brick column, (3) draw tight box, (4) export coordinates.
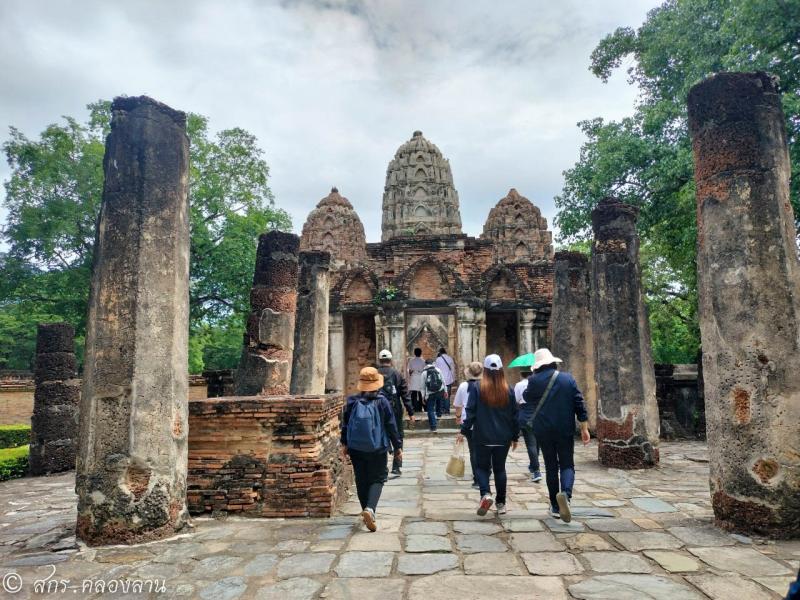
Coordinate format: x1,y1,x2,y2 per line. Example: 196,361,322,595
291,252,331,395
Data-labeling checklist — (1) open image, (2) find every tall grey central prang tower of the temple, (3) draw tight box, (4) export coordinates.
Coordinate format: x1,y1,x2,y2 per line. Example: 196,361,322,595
381,131,462,242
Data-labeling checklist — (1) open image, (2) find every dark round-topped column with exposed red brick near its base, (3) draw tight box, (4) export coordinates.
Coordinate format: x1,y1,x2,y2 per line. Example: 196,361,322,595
592,198,659,469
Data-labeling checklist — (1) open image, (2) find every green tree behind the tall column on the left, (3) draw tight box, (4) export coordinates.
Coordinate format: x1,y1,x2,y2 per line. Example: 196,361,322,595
0,101,291,372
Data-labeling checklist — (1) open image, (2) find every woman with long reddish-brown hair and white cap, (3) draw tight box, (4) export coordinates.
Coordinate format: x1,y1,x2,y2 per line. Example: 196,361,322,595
461,354,519,516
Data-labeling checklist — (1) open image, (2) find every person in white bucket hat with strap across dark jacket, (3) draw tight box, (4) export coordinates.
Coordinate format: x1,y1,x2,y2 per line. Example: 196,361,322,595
519,348,589,523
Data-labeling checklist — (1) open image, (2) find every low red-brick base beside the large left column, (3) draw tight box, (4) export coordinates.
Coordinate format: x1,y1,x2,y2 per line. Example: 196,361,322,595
187,395,353,517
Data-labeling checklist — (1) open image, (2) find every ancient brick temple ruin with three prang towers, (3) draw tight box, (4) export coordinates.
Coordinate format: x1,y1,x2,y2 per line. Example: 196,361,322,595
300,131,553,391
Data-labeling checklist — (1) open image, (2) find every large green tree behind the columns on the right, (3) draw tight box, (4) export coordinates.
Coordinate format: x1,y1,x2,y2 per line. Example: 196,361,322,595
555,0,800,362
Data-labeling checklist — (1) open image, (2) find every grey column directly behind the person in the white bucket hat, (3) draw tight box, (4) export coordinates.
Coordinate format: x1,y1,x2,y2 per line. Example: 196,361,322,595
550,252,597,431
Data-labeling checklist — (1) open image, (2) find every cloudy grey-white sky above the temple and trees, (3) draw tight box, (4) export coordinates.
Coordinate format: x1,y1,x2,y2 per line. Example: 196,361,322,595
0,0,658,241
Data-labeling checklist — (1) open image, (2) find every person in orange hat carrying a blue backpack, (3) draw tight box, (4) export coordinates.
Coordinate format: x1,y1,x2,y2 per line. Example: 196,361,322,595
340,367,403,531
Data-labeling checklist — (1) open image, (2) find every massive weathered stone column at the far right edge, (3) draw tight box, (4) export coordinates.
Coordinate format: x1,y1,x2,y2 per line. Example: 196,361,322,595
688,73,800,537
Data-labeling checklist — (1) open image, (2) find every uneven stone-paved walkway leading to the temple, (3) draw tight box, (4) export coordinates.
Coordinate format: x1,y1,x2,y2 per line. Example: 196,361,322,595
0,435,800,600
